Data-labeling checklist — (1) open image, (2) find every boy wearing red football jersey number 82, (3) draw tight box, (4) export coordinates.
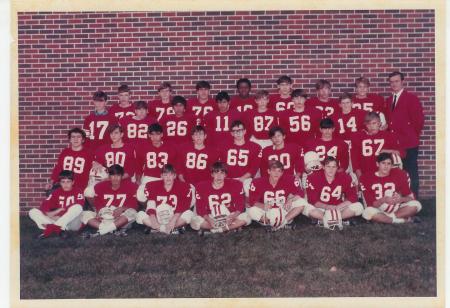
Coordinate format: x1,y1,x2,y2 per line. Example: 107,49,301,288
119,101,156,148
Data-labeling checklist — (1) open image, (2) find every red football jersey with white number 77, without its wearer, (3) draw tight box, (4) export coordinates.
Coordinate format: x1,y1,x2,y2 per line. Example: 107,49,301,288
94,179,138,213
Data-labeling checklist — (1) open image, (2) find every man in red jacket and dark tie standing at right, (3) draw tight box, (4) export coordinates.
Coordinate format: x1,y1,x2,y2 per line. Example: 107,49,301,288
386,71,424,198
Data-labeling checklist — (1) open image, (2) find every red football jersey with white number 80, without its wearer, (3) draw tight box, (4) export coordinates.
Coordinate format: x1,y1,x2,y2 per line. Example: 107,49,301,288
95,143,136,177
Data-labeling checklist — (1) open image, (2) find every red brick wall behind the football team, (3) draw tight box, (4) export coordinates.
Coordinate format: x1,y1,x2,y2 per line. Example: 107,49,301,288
18,10,436,210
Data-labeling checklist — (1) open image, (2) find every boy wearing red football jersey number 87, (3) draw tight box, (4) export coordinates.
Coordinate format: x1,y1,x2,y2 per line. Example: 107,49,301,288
242,90,278,149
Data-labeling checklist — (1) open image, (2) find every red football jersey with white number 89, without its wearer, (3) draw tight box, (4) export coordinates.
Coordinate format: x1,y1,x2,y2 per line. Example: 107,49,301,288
51,147,94,189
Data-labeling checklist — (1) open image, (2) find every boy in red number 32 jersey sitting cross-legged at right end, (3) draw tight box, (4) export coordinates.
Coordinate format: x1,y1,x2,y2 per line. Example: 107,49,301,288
360,153,422,223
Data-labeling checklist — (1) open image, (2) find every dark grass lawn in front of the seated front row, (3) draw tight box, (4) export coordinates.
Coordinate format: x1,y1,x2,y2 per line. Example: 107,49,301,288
20,200,436,299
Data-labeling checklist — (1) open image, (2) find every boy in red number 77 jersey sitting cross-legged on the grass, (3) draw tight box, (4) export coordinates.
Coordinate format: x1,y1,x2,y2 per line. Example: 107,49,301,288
81,165,138,238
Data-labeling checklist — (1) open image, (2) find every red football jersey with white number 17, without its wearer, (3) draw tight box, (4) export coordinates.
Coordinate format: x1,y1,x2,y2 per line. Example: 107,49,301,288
83,112,117,151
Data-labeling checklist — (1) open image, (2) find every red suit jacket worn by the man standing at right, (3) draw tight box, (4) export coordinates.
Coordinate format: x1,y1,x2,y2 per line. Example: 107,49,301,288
386,90,424,149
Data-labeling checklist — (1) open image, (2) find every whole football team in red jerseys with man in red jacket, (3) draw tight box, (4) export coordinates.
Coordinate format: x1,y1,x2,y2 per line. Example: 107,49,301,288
29,71,424,238
